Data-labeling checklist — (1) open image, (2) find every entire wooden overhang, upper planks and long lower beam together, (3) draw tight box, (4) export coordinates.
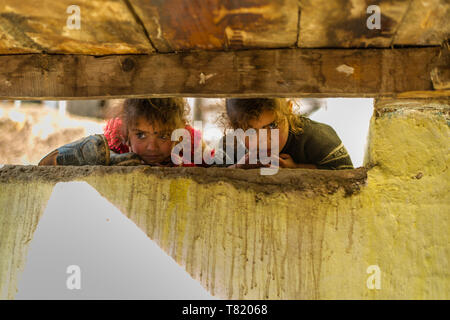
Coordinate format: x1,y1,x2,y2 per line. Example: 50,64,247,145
0,0,450,99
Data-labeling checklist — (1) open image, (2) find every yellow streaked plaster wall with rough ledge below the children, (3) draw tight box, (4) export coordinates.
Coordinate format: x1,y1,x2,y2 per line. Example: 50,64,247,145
0,100,450,299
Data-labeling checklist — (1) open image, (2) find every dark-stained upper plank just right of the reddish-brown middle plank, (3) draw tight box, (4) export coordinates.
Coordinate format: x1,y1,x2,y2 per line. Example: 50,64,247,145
298,0,409,48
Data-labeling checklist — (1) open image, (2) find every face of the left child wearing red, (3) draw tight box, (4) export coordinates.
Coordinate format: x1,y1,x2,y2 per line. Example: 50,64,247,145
128,119,173,164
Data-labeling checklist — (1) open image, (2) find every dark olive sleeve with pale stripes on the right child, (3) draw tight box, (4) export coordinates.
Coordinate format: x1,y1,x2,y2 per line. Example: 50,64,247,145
305,122,353,170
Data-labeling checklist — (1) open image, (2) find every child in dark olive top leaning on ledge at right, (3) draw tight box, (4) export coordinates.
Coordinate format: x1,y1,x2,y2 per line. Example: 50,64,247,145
216,98,353,169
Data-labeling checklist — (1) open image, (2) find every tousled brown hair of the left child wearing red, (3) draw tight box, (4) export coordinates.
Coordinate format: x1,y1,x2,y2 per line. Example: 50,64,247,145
120,98,189,141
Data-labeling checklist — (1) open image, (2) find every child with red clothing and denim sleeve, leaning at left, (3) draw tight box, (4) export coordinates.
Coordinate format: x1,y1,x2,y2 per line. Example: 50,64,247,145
39,98,210,166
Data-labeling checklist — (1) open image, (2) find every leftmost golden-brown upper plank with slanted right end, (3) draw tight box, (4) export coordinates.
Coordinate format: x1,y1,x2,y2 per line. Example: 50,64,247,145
0,0,155,55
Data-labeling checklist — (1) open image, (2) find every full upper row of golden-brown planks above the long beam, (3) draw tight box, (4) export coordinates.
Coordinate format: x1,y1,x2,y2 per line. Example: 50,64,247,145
0,0,450,55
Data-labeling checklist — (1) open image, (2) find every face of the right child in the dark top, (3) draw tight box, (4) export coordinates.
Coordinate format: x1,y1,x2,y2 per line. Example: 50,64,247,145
245,110,289,155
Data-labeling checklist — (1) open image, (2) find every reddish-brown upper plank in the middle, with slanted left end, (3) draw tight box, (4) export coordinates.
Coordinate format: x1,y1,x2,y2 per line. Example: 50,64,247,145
129,0,298,52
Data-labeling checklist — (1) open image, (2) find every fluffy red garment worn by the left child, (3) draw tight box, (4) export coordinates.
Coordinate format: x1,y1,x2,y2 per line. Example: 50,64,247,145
103,117,214,167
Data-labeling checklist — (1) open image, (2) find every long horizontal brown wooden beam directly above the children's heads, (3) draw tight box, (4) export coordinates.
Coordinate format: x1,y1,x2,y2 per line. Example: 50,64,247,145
0,47,450,100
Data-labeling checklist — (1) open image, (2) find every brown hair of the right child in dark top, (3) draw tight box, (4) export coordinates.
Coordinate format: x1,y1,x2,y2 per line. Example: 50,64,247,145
225,98,302,133
